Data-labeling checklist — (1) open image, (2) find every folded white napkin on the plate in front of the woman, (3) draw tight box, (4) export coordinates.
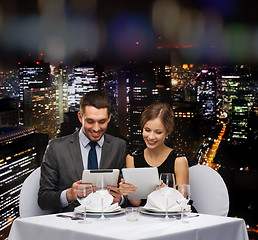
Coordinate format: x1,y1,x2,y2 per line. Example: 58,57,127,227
143,187,190,212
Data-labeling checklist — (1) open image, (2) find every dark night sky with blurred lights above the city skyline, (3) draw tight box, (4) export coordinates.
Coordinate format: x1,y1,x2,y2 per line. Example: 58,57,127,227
0,0,258,70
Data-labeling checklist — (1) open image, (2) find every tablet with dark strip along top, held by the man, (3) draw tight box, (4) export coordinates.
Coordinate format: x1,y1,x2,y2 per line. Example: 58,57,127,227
82,169,119,188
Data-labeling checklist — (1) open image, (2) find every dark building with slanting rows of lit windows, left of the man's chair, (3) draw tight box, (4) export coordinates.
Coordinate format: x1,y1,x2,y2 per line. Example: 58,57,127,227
0,127,48,239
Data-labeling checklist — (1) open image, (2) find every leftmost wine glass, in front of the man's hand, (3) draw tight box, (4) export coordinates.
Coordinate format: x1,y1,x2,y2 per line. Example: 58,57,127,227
76,183,93,224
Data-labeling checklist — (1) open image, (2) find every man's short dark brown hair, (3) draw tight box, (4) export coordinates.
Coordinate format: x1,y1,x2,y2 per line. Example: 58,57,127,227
80,91,111,116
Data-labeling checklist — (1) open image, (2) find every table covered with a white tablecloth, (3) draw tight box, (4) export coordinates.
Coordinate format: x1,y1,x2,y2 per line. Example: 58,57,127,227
8,213,248,240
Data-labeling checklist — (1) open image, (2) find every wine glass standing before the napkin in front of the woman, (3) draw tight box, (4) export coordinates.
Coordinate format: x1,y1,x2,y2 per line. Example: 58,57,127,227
159,173,175,221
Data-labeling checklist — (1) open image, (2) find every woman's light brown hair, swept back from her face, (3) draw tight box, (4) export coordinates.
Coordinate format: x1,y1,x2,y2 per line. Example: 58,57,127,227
140,102,174,134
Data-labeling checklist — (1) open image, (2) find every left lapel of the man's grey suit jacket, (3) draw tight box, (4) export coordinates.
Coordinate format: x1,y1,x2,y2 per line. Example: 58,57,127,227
68,131,84,179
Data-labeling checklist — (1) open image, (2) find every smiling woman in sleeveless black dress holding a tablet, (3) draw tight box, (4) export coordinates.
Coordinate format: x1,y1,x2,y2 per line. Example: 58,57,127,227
119,102,189,206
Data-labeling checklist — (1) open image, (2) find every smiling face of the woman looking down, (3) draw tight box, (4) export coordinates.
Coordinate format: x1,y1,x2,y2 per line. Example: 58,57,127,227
142,118,168,149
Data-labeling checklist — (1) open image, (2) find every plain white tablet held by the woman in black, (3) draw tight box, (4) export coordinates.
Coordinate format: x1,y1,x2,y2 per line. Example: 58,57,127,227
122,167,159,199
